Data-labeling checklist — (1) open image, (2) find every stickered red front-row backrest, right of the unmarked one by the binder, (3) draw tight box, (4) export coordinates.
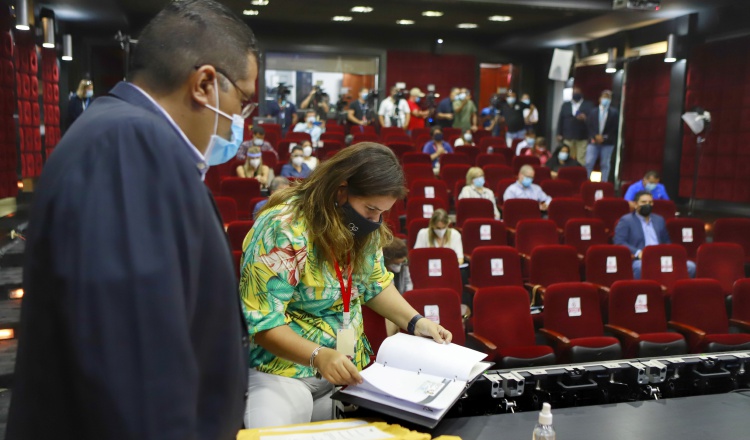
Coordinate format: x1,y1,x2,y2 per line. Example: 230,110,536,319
543,283,604,339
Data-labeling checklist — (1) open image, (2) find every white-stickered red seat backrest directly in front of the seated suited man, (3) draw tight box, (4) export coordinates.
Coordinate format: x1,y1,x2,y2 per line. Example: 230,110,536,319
641,244,689,292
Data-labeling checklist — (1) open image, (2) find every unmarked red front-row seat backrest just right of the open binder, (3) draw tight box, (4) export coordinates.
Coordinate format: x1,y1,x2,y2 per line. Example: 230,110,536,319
474,286,536,349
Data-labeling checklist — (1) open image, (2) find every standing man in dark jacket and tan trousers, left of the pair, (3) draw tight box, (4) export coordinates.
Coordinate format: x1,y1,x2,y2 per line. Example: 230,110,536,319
557,87,594,161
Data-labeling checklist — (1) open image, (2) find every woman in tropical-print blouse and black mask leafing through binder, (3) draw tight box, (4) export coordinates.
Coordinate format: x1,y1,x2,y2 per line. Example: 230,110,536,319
239,142,452,428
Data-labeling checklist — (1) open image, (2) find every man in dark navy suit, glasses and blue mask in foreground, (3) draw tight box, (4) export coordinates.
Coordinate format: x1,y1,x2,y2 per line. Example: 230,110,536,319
6,0,258,440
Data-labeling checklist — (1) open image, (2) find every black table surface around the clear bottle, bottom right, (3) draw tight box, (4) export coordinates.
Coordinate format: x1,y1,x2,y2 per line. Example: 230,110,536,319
431,392,750,440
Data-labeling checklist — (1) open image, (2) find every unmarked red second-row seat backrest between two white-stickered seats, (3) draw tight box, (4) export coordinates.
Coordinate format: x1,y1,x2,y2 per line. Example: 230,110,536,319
529,245,581,286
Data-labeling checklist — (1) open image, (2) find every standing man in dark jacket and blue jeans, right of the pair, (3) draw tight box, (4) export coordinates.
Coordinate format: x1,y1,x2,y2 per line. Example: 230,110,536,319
585,90,620,182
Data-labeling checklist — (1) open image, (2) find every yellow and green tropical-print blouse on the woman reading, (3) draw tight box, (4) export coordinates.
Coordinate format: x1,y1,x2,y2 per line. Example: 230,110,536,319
240,204,393,378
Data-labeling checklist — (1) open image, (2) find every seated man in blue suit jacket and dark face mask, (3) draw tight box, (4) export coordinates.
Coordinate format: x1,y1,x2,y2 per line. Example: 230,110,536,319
613,190,695,280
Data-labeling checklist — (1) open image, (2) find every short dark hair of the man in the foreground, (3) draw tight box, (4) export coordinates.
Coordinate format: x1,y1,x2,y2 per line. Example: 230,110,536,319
131,0,258,93
